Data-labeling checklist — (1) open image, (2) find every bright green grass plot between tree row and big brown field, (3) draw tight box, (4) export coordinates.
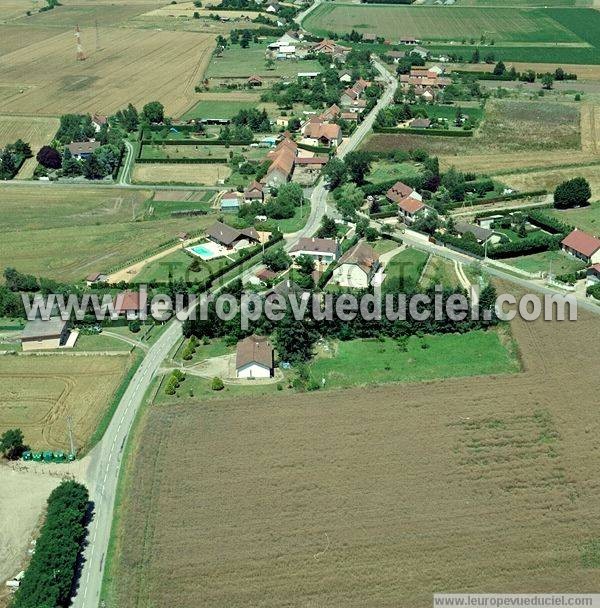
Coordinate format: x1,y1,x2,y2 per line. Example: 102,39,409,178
311,331,519,388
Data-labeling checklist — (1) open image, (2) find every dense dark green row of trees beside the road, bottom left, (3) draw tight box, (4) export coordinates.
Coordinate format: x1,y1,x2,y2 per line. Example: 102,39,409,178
11,481,89,608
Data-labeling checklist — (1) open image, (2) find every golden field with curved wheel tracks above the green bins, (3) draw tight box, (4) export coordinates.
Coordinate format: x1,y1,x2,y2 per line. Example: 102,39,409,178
0,353,133,450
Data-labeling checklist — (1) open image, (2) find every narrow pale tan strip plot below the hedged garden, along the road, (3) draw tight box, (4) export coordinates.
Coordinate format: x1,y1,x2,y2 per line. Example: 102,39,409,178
132,163,231,186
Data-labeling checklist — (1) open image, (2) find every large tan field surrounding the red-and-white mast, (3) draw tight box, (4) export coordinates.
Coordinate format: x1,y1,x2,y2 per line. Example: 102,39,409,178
0,27,214,116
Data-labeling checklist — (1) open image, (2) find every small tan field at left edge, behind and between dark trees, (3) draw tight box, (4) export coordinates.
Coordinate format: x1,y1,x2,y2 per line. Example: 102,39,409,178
0,116,60,179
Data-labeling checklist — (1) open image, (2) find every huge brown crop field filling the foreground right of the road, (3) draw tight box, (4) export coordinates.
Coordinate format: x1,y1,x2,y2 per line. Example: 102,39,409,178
105,306,600,608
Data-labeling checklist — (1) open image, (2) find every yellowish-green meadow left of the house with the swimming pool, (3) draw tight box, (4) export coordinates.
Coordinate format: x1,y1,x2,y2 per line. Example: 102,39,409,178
0,184,214,281
